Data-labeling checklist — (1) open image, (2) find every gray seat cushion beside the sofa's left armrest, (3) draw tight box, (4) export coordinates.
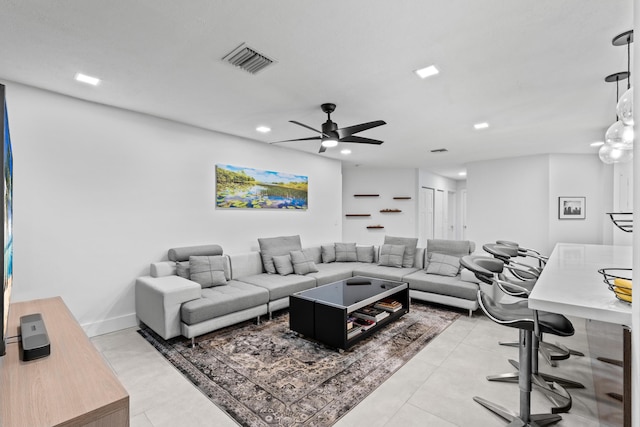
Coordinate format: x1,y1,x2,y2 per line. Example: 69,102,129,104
180,280,269,325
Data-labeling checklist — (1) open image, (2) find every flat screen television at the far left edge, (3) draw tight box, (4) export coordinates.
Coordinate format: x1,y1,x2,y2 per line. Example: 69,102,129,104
0,84,13,356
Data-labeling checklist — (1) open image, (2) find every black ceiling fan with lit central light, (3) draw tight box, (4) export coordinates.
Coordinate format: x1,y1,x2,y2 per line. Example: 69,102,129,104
271,104,386,153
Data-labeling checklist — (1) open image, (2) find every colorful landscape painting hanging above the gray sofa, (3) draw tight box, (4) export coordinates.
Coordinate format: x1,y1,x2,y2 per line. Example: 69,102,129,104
216,165,309,210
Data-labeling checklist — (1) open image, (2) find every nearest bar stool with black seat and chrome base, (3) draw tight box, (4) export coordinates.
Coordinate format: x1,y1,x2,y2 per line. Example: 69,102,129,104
460,256,574,425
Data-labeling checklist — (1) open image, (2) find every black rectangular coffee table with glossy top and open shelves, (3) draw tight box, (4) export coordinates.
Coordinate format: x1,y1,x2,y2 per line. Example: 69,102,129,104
289,276,409,350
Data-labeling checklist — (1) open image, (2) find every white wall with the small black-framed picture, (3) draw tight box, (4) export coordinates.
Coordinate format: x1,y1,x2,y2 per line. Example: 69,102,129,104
467,154,613,253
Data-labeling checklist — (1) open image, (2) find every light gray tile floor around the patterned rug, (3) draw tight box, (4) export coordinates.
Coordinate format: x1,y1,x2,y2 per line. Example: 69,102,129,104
92,312,622,427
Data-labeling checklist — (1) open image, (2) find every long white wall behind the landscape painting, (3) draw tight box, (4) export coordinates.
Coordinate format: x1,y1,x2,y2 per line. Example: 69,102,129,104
7,83,342,335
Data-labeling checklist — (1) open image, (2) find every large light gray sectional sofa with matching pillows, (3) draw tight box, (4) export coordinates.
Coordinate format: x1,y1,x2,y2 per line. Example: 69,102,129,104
135,236,478,340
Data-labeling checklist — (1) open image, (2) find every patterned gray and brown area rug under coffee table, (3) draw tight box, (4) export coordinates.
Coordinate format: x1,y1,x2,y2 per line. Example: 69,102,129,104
139,303,460,427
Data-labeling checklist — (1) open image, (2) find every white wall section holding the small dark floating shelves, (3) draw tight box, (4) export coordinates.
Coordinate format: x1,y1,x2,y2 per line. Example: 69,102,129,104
340,167,418,245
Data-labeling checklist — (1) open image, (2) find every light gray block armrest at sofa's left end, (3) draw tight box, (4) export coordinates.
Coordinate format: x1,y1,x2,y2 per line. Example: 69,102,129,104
135,276,202,339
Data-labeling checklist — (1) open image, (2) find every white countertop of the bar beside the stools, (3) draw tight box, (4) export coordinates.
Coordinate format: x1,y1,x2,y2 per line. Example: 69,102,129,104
529,243,633,327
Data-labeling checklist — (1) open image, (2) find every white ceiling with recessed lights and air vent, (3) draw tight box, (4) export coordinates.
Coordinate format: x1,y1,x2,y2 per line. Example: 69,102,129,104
0,0,633,178
